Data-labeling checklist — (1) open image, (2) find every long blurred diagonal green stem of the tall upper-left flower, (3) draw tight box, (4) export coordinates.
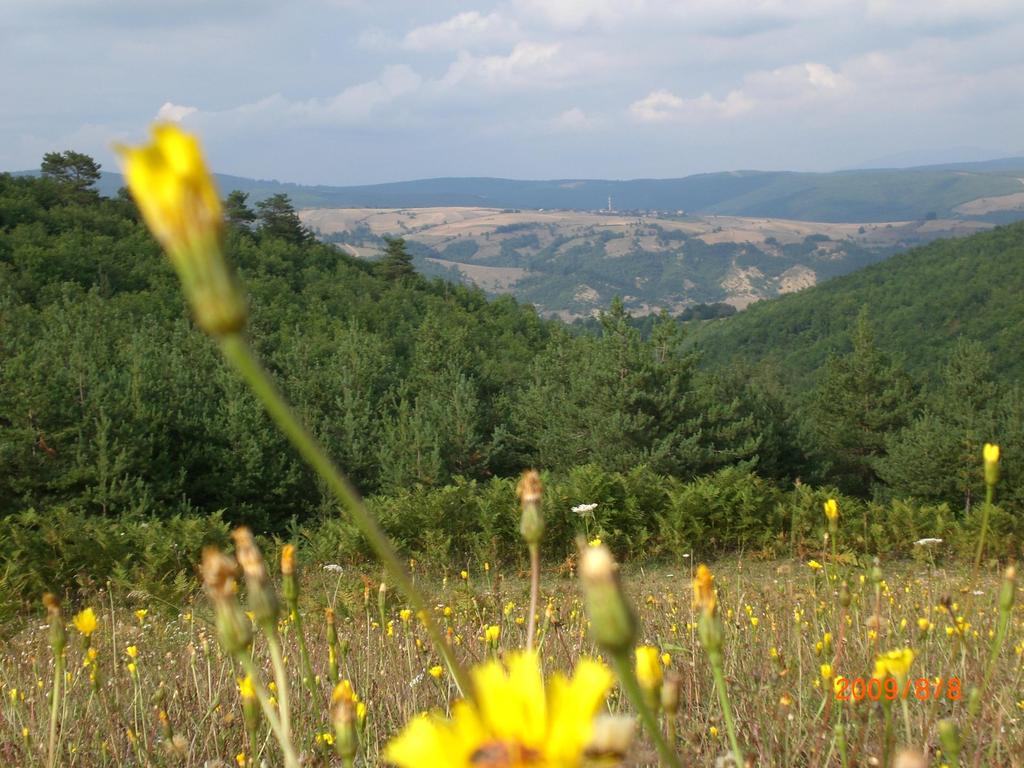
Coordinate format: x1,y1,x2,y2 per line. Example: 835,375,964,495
218,333,473,698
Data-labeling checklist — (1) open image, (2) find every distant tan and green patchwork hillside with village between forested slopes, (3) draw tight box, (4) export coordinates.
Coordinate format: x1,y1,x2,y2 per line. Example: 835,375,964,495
301,207,991,321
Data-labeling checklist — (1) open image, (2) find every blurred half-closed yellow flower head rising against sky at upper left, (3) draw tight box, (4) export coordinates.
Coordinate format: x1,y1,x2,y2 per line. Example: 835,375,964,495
115,124,246,335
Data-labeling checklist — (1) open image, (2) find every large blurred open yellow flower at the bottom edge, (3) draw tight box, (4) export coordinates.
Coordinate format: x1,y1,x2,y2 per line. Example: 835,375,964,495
384,652,612,768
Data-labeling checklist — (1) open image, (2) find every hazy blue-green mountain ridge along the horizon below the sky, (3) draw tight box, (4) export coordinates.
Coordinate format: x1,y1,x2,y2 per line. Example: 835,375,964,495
12,157,1024,223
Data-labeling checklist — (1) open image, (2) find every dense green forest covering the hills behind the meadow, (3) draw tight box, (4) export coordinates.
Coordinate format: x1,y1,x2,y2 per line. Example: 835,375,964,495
0,157,1024,548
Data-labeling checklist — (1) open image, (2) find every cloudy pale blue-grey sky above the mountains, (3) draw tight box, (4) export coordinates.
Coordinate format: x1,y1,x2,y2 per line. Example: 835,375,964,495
6,0,1024,184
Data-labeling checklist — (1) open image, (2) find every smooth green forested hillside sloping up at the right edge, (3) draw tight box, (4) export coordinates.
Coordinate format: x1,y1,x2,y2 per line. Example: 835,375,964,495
693,222,1024,389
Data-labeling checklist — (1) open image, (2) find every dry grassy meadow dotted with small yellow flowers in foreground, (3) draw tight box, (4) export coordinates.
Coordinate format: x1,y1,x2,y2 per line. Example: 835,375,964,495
0,558,1024,767
